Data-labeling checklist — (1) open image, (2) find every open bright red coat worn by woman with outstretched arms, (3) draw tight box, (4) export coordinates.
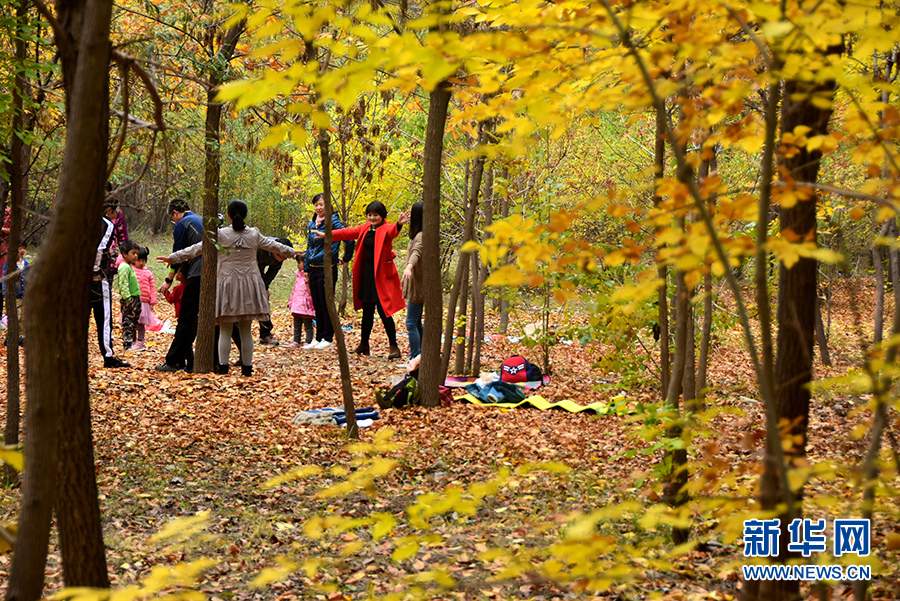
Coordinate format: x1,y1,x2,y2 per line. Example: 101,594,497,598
331,222,406,316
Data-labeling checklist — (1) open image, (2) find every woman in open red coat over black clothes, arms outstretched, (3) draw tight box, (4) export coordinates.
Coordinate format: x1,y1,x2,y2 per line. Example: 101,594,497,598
331,200,409,359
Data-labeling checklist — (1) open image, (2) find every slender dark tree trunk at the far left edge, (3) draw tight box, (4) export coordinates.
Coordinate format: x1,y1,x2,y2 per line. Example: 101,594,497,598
3,0,28,485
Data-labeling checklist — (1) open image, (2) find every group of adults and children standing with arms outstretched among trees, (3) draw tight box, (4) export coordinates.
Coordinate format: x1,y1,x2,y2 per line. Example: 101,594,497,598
93,194,424,376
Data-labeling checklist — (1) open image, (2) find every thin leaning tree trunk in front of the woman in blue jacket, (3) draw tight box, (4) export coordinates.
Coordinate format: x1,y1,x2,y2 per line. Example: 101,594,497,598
319,128,359,439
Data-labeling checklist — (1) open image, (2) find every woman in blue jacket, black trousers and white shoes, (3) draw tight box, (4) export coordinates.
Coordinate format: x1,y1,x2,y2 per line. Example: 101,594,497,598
303,193,355,350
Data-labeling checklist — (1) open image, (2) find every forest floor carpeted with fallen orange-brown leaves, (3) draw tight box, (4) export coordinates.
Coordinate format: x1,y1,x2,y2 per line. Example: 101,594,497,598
0,268,900,601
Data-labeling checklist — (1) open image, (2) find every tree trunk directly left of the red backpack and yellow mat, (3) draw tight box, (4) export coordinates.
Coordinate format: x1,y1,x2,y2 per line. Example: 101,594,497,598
419,81,453,407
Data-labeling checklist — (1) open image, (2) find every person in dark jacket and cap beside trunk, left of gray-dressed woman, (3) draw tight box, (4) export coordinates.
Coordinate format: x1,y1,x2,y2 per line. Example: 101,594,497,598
156,198,203,372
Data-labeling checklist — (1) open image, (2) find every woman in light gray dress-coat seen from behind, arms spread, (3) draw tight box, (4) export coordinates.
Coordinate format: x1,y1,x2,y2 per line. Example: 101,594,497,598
159,200,295,376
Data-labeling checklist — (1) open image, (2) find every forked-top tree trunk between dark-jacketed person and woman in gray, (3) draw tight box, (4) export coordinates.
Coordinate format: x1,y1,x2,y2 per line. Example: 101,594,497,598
194,21,245,374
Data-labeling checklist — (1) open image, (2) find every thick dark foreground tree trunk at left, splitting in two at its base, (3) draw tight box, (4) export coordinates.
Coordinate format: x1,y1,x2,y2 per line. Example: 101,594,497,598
6,0,112,601
